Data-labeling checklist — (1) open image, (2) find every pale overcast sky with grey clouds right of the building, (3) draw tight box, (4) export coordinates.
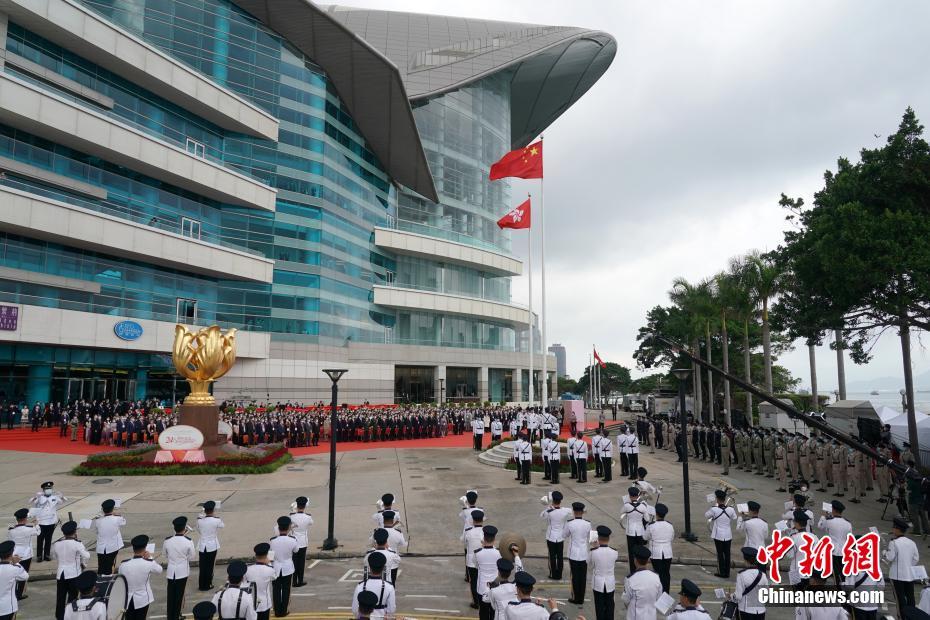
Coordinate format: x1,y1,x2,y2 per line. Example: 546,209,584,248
340,0,930,390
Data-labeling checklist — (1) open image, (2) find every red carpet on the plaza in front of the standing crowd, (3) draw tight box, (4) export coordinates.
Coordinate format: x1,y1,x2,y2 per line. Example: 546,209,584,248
0,422,616,456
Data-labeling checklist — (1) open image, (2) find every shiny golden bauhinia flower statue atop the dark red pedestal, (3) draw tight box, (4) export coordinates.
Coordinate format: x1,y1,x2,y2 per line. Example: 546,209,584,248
171,325,236,405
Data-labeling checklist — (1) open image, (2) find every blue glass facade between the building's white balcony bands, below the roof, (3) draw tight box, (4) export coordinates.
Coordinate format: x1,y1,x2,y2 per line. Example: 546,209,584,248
0,0,525,358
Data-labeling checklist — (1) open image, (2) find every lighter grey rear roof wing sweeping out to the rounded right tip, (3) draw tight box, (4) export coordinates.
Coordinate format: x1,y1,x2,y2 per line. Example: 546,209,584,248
321,5,617,148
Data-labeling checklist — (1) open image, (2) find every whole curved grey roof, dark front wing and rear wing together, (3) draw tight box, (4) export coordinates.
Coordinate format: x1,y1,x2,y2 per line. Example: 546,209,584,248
232,0,617,202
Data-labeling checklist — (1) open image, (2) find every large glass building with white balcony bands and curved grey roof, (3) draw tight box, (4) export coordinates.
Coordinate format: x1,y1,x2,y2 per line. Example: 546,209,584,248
0,0,616,402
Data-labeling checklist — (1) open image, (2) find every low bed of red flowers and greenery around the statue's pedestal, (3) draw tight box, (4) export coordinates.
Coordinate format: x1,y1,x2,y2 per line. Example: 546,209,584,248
71,443,291,476
